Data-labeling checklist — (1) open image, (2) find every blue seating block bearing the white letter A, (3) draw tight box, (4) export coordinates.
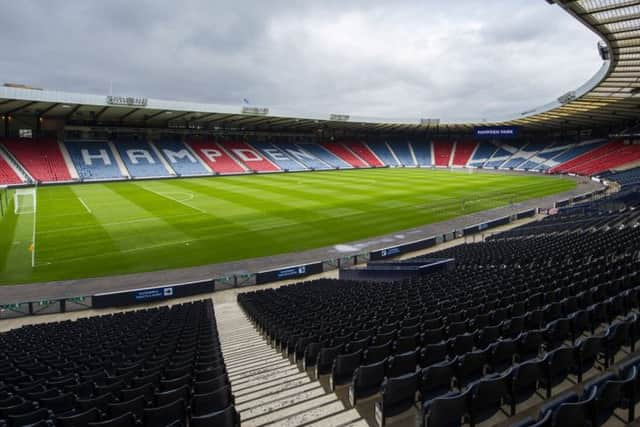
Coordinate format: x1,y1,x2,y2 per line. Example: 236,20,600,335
114,139,175,178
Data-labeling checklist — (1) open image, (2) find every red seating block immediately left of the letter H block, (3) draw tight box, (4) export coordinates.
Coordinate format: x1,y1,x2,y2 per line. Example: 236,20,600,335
4,139,71,182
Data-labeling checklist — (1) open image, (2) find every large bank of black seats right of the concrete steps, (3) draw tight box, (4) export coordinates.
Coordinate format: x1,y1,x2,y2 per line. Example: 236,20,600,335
238,203,640,426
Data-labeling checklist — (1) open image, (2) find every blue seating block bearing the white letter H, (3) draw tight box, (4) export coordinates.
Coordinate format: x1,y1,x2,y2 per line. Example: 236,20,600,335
64,141,123,180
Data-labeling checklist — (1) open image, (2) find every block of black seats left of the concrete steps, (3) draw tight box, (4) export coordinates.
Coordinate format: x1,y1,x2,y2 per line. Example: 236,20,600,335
0,300,240,427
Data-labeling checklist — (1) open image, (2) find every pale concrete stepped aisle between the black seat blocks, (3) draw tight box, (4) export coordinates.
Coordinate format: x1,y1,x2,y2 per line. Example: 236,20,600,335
215,301,367,427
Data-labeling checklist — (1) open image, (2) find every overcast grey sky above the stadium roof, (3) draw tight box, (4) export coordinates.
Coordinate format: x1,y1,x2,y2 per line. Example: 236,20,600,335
0,0,601,120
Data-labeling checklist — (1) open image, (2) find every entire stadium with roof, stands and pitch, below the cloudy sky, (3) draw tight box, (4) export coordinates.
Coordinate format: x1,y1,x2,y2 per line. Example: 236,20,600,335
0,0,640,427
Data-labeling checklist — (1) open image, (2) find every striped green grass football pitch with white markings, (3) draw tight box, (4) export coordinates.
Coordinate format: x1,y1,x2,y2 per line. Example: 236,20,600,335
0,169,575,284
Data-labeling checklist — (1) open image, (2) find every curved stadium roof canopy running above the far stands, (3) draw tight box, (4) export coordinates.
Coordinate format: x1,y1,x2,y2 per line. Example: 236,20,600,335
0,0,640,132
